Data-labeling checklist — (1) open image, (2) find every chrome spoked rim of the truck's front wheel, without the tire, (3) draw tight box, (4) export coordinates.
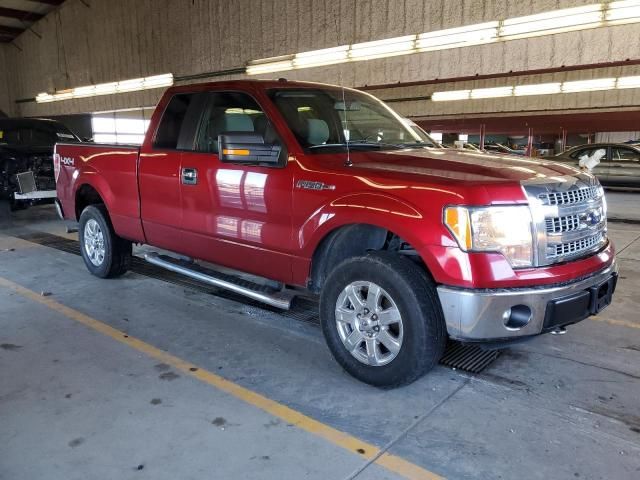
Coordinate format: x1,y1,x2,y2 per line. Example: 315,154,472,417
336,282,403,367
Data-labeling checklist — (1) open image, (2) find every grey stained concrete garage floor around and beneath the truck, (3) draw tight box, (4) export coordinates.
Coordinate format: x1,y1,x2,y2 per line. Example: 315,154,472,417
0,202,640,480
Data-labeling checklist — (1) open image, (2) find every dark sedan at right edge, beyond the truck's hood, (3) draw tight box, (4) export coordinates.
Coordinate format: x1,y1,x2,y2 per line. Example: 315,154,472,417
548,143,640,188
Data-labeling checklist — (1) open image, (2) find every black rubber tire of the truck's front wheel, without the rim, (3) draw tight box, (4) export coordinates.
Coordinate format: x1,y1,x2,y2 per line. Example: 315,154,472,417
320,253,447,388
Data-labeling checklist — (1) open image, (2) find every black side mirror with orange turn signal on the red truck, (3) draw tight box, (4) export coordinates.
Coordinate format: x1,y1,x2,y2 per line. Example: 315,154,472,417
218,132,282,164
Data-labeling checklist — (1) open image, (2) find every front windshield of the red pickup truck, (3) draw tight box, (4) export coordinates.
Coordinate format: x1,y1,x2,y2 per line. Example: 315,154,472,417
269,88,436,153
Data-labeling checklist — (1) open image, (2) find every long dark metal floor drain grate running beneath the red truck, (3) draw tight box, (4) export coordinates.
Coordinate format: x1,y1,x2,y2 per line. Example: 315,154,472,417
16,231,500,373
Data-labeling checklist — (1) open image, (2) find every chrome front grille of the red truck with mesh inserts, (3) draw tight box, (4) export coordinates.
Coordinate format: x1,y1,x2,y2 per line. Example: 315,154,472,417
524,174,607,266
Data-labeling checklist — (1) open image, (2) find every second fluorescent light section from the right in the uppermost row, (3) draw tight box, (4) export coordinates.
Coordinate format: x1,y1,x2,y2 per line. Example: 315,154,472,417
500,3,603,38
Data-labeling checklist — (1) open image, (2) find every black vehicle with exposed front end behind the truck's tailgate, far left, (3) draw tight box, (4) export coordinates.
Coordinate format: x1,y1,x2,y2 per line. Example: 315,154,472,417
0,118,80,210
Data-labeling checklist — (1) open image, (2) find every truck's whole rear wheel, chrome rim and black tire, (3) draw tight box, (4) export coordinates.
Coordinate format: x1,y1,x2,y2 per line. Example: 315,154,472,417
79,205,132,278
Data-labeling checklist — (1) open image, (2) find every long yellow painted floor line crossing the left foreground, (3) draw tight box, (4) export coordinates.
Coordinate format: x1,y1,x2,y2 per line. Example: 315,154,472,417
0,277,443,480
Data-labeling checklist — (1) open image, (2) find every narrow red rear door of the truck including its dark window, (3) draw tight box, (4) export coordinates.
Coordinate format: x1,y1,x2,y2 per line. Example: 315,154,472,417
138,93,205,252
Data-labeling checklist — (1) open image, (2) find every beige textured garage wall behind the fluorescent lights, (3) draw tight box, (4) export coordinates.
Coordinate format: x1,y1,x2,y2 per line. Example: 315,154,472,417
5,0,640,116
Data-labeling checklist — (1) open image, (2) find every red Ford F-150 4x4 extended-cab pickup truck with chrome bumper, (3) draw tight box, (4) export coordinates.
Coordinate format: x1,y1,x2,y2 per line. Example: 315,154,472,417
54,80,617,386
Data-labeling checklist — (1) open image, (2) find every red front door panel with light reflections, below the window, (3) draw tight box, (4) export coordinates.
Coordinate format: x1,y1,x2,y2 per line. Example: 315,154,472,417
182,152,293,282
